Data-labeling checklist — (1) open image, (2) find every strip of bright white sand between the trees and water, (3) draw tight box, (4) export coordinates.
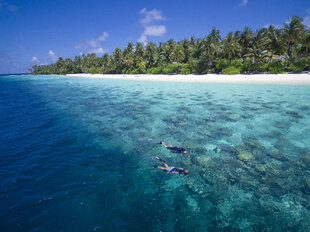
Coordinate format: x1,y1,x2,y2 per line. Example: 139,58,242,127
66,74,310,85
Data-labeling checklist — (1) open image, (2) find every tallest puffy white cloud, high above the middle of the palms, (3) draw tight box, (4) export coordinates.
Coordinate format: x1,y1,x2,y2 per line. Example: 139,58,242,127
138,8,167,44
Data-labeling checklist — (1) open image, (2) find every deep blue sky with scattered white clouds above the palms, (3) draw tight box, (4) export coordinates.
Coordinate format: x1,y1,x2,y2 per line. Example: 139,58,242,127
0,0,310,74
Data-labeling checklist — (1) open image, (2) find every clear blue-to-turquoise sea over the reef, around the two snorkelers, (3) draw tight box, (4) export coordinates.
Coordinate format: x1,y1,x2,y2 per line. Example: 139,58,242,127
0,76,310,231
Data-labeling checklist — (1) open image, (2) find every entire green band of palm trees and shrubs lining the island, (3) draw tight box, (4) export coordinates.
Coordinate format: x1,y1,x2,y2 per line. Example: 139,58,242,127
31,16,310,74
